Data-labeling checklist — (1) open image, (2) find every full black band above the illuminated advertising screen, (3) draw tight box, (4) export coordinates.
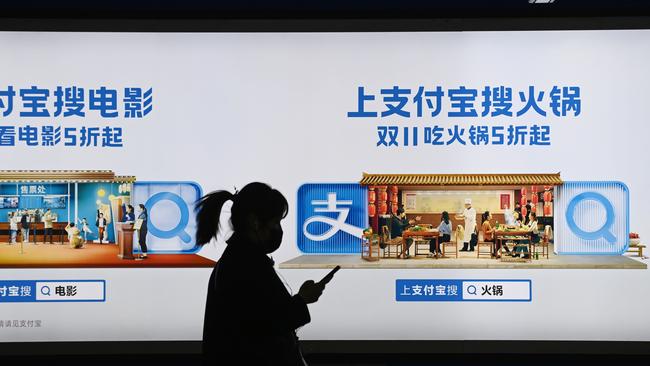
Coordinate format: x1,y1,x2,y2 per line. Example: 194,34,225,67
0,0,650,32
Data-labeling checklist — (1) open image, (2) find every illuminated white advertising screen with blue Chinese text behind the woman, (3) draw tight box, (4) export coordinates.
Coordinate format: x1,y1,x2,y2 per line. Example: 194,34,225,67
0,30,650,342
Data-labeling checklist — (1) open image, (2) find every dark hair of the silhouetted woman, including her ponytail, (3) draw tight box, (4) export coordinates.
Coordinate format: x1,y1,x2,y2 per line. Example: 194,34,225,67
196,182,289,245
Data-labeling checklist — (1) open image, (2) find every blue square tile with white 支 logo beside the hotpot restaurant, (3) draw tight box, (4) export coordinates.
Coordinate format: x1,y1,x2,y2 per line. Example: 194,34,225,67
297,183,368,253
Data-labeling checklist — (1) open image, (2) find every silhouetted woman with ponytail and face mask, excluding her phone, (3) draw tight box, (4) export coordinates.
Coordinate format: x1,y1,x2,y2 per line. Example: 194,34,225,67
196,183,324,365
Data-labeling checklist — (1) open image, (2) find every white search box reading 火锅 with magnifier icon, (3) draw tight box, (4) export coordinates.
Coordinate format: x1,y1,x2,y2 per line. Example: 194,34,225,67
463,280,532,301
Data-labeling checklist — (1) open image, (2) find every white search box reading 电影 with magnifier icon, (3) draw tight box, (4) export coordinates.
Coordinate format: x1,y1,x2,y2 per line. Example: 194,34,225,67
36,280,106,301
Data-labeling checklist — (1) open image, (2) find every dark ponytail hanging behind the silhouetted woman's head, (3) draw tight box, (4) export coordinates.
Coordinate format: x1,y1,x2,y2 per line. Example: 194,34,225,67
195,191,234,245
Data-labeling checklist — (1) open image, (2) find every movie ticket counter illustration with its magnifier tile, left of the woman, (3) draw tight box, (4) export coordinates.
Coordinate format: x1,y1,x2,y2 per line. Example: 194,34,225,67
0,170,214,268
